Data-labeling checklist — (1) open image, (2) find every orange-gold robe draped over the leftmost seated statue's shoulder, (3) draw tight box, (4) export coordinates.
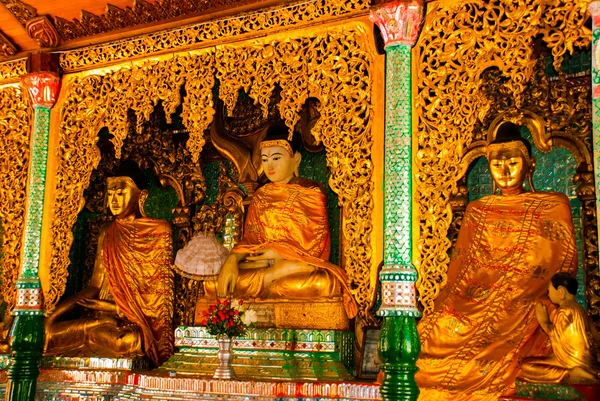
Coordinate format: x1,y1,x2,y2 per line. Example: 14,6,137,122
103,218,173,366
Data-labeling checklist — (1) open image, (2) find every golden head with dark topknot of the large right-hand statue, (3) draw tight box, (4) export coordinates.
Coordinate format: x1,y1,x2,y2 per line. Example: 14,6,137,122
486,121,535,195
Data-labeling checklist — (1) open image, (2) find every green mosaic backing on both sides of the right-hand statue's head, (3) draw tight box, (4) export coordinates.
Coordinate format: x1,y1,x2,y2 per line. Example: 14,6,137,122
467,129,585,307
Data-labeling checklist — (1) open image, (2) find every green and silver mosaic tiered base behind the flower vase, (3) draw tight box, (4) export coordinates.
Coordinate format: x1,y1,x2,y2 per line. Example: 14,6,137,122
158,326,354,382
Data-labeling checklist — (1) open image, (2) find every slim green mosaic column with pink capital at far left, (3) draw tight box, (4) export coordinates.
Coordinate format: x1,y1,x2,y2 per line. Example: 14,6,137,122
6,73,60,401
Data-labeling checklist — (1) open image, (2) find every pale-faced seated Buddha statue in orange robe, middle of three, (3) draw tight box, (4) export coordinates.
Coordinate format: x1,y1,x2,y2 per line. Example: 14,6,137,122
210,124,357,318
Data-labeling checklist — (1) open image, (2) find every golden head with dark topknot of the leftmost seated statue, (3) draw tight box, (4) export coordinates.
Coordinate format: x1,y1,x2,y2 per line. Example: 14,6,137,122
106,160,148,219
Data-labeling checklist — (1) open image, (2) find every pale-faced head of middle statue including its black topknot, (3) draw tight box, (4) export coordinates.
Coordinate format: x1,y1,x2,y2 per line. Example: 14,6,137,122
260,123,302,184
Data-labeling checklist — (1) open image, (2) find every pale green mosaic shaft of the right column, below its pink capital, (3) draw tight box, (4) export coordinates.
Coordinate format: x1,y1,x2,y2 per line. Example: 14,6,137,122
384,45,412,265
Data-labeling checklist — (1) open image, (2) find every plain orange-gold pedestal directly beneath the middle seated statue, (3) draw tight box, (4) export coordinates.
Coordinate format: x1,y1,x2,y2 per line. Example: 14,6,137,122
194,297,350,331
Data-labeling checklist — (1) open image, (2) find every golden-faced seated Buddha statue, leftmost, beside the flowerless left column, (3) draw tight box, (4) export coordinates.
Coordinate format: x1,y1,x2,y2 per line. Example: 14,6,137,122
45,161,173,366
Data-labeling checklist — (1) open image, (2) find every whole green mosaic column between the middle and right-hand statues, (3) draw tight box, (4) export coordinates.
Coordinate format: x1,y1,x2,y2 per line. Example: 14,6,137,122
371,1,423,400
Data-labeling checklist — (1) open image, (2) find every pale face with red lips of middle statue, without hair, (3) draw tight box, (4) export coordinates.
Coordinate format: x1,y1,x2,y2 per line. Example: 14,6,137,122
261,140,301,184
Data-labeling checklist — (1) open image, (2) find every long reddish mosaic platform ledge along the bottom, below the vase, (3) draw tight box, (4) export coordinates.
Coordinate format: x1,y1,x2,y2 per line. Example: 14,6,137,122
0,369,381,401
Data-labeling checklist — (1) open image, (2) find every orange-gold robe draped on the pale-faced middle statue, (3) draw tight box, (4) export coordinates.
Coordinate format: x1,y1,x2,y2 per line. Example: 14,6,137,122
232,178,357,318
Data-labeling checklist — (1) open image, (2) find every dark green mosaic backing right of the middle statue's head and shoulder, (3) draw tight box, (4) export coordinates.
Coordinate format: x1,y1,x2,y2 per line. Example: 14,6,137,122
298,148,340,264
